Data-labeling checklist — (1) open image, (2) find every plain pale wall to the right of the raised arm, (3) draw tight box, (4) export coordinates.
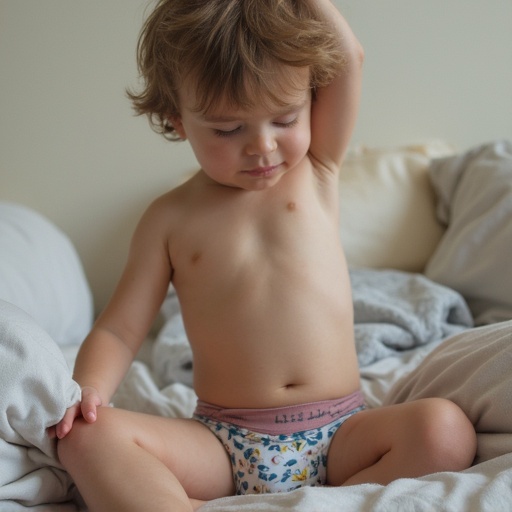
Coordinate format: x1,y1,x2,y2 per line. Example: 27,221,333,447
344,0,512,150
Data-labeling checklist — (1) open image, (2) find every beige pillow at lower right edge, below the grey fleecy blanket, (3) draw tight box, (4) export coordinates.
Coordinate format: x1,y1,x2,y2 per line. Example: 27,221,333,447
383,321,512,463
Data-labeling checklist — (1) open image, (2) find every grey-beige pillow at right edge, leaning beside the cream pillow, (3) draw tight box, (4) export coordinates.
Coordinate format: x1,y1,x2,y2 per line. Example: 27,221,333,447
425,141,512,324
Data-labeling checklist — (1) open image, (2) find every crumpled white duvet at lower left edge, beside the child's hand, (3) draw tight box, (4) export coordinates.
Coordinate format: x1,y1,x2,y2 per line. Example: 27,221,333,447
0,301,80,511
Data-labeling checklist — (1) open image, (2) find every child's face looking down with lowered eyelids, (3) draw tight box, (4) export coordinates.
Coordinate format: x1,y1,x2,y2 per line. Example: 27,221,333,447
172,68,311,190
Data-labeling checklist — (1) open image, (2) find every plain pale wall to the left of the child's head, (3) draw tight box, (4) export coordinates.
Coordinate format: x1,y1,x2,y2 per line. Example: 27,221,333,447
0,0,195,308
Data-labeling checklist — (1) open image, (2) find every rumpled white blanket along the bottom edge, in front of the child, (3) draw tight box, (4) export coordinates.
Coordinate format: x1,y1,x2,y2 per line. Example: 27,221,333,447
201,454,512,512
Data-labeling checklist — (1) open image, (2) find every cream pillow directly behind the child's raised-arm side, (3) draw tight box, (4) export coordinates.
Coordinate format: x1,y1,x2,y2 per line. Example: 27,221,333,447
339,141,453,272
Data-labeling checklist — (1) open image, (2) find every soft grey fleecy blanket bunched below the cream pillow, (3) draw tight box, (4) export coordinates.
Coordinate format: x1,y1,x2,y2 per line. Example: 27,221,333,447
350,269,473,366
